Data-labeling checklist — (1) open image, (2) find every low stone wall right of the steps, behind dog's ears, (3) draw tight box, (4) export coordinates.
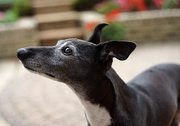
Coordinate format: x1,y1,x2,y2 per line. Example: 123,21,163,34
81,9,180,42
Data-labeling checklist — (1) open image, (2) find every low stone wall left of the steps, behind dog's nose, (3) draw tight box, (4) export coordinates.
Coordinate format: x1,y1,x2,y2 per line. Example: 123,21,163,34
0,18,38,58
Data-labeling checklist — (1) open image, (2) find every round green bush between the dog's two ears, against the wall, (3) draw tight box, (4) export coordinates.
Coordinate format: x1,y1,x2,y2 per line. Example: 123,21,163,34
102,22,125,40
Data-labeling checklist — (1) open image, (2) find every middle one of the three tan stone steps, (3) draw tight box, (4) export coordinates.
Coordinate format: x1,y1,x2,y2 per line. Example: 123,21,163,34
34,11,79,30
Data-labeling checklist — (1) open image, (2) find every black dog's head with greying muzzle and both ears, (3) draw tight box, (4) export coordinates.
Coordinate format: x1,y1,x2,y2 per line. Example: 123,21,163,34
17,23,136,83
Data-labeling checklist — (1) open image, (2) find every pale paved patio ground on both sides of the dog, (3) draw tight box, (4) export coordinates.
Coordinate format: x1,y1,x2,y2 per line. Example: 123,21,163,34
0,42,180,126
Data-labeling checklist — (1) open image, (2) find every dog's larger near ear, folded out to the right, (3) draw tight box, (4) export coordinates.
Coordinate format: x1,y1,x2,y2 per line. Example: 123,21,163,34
97,41,136,72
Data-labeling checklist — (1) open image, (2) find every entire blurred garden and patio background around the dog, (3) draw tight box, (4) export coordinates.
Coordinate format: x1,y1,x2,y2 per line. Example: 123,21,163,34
0,0,180,126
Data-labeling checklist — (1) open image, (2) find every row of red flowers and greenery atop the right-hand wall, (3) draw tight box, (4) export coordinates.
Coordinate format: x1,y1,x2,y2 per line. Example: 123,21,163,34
94,0,180,14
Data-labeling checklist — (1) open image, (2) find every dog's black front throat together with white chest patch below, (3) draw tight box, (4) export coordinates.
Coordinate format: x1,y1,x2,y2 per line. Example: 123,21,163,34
69,70,115,126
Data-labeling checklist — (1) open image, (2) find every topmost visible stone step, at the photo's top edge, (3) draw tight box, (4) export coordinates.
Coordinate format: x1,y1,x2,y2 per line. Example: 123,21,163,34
31,0,72,14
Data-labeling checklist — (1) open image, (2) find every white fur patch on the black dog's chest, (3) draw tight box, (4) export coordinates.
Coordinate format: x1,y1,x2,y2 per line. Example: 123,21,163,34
81,101,111,126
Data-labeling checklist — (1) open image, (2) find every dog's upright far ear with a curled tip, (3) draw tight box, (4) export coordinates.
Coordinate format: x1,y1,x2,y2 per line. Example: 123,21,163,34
87,23,108,44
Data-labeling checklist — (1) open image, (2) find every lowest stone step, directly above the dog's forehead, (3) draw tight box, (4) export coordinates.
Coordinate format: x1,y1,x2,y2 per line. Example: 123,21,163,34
39,27,83,46
